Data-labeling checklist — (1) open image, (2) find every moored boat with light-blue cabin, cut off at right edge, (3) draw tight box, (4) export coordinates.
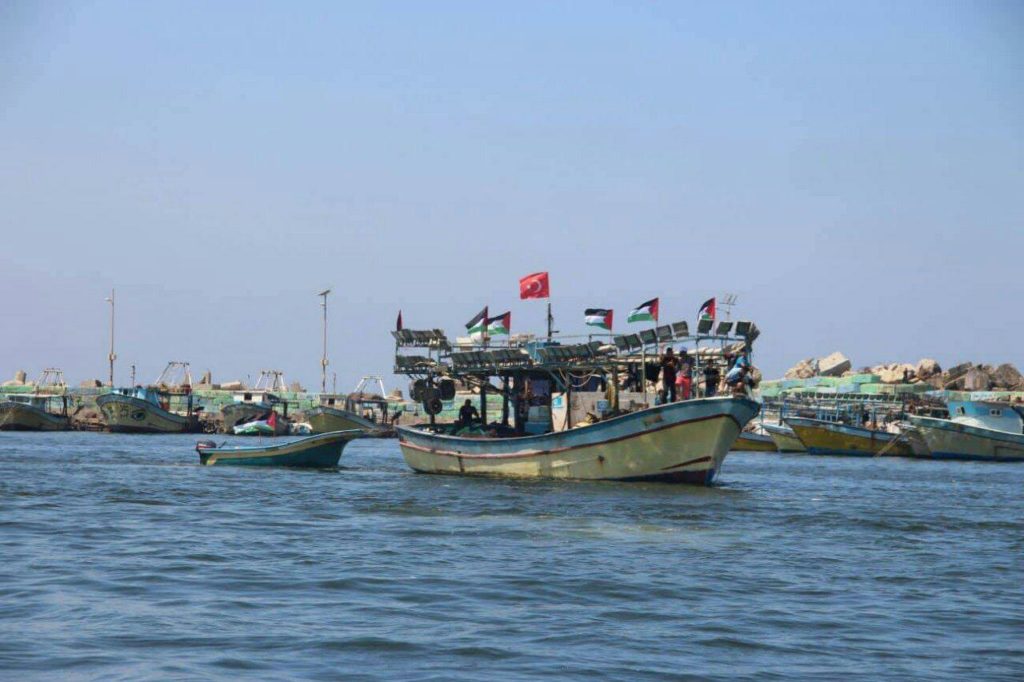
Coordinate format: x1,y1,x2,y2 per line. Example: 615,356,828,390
908,400,1024,462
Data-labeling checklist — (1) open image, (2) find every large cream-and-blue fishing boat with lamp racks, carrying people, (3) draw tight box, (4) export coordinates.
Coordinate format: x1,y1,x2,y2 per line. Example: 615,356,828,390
394,313,759,484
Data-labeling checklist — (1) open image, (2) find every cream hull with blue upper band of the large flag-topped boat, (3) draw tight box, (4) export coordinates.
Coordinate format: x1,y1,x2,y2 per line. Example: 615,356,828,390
397,397,759,485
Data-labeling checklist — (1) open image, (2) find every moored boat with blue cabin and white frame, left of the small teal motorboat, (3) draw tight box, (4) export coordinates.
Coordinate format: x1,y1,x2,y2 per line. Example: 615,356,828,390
96,361,200,433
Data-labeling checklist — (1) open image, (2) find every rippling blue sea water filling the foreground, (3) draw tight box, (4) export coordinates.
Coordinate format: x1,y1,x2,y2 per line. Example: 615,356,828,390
0,433,1024,680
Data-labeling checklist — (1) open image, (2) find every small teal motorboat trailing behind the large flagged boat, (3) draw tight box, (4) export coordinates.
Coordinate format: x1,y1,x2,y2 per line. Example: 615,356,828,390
196,429,362,469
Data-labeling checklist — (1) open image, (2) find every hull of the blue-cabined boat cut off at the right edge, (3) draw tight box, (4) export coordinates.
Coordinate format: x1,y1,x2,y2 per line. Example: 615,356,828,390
910,416,1024,462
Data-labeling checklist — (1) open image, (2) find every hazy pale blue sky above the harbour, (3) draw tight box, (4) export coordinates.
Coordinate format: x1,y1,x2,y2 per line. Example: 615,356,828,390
0,0,1024,390
